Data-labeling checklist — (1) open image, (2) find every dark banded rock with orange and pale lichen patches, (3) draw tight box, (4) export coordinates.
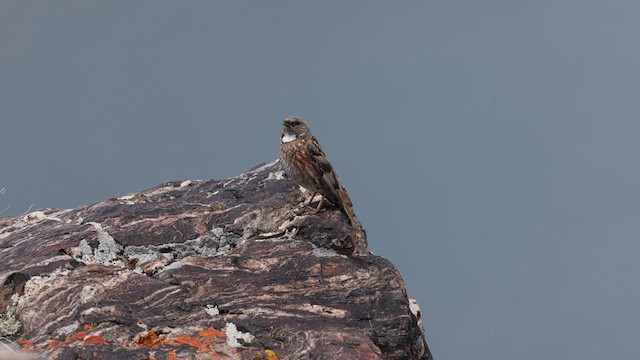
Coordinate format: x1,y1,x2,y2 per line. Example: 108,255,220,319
0,162,431,359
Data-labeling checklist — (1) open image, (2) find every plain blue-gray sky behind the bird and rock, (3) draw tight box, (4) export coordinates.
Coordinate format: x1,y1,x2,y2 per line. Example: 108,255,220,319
0,0,640,360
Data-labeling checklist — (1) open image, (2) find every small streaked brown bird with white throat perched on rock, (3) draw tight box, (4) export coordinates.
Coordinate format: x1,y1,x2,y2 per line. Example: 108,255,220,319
280,116,357,225
